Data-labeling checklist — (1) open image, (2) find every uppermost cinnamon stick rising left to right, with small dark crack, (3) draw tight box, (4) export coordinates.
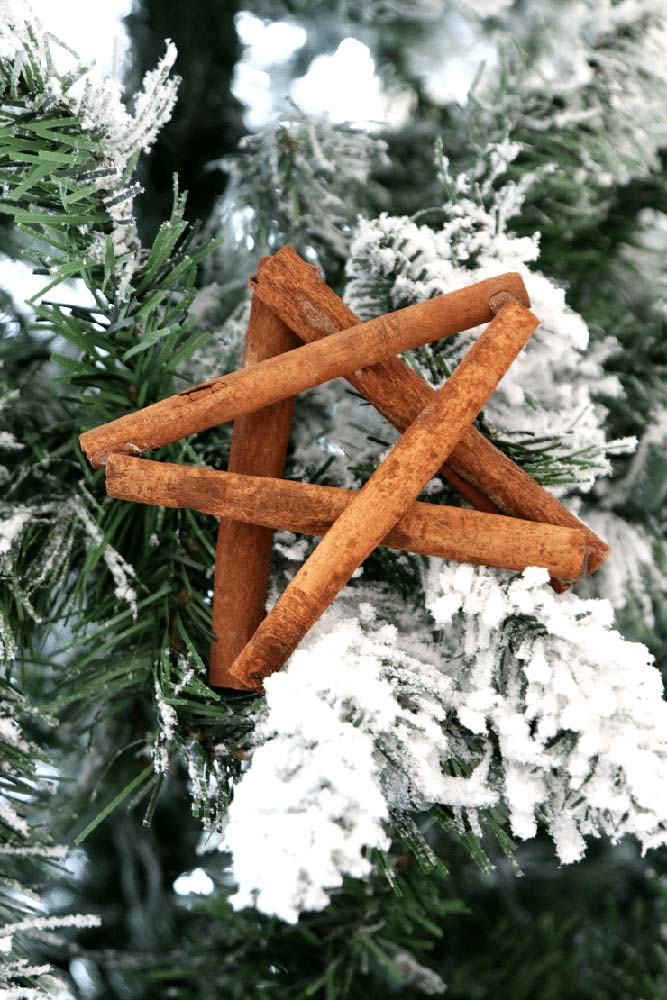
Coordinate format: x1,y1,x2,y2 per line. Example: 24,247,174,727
79,273,530,466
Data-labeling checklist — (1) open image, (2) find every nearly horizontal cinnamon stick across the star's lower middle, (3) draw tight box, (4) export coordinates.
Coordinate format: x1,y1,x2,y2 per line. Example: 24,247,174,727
105,455,586,584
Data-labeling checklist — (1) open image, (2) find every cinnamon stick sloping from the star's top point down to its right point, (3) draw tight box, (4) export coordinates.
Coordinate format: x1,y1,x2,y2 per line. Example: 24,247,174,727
251,246,609,573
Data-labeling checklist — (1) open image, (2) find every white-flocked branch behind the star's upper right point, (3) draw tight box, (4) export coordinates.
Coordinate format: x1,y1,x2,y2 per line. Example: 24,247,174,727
346,142,633,492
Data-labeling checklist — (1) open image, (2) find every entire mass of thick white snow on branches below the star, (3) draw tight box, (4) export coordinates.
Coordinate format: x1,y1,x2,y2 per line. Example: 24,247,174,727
223,559,667,922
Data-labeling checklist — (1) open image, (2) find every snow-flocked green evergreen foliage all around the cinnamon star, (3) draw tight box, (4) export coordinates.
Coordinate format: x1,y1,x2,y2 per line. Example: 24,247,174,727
0,0,667,1000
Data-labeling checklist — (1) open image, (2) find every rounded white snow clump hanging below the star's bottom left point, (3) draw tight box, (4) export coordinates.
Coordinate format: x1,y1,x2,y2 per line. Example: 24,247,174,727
224,627,395,923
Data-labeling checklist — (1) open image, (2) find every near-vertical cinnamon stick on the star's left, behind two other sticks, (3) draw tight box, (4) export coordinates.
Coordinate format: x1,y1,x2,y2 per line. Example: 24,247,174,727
208,292,301,688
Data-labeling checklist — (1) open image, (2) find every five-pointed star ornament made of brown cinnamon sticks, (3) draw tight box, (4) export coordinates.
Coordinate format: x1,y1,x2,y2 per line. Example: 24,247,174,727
80,246,609,690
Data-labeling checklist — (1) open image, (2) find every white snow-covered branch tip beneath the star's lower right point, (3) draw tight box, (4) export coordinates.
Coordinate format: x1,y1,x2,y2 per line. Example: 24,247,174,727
426,562,667,862
